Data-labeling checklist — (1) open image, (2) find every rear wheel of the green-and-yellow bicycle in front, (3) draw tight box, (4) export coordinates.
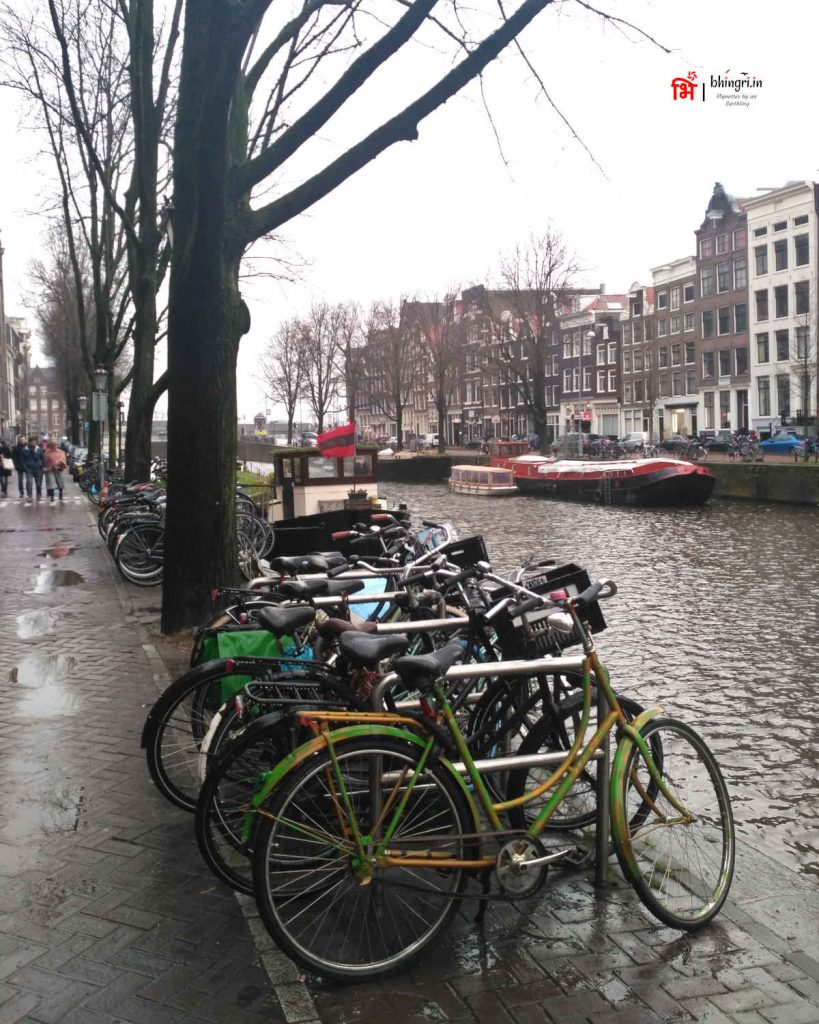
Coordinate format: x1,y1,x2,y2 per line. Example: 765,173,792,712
253,736,474,980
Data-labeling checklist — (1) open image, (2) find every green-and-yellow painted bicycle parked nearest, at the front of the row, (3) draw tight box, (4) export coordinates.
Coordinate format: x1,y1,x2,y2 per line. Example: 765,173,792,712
245,582,735,980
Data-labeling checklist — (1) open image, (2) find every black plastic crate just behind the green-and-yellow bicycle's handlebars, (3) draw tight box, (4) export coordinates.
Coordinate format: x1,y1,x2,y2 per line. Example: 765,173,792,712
493,563,606,658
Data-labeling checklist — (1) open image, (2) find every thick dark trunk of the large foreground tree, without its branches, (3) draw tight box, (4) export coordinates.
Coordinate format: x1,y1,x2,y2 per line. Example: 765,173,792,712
162,0,250,633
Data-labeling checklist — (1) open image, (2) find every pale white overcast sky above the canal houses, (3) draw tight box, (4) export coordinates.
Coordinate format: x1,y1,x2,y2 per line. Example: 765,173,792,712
0,0,819,417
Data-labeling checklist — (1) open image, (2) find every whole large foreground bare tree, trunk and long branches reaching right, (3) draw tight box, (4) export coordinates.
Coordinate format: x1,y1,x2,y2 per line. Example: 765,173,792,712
163,0,581,632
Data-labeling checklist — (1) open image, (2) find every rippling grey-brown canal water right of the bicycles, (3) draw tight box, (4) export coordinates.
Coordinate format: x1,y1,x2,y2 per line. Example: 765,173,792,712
379,483,819,877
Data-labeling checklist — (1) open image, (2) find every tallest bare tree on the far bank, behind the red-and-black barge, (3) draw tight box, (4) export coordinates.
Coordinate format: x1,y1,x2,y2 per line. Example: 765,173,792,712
483,237,579,452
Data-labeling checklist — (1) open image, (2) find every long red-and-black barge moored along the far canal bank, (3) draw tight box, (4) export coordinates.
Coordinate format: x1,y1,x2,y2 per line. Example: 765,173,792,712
508,456,716,507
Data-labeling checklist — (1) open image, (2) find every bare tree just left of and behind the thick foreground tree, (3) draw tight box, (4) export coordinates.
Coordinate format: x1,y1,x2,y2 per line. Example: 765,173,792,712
0,0,182,477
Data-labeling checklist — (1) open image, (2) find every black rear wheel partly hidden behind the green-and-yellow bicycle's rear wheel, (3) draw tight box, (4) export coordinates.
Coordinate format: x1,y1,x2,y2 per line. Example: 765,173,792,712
195,714,297,896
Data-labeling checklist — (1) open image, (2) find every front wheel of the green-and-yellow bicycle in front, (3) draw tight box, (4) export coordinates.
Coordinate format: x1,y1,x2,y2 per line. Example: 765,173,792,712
611,718,734,931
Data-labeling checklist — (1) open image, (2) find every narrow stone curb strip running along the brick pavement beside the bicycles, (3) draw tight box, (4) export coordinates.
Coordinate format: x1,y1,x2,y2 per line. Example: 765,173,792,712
88,501,320,1024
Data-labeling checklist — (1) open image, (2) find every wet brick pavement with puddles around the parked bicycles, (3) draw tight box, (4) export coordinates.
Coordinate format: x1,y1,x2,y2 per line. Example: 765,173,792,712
0,485,819,1024
